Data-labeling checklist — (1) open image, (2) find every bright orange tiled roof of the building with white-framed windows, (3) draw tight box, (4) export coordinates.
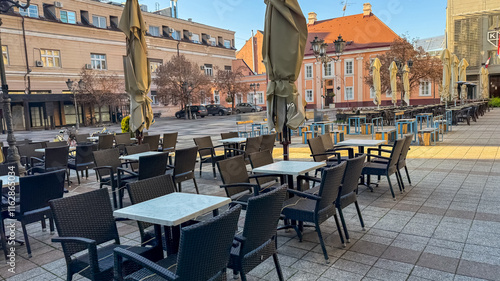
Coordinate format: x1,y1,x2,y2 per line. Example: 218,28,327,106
305,14,398,55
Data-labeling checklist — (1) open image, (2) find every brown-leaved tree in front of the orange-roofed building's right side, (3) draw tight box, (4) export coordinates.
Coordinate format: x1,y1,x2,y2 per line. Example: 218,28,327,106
364,35,443,102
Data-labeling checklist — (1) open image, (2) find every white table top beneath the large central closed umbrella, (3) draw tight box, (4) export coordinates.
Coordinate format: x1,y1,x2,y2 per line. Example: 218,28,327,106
252,161,326,176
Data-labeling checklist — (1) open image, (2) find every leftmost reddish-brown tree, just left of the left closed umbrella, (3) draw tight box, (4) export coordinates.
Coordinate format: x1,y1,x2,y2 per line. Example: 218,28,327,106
77,68,124,124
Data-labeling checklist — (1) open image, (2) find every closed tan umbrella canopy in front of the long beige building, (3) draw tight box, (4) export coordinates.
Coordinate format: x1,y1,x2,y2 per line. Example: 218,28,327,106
118,0,154,132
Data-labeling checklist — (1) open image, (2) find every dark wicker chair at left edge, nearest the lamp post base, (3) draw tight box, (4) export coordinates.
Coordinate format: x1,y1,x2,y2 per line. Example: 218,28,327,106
2,169,66,258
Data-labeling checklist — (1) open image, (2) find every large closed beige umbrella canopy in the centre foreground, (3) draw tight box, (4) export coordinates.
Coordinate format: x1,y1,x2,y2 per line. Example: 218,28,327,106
262,0,307,132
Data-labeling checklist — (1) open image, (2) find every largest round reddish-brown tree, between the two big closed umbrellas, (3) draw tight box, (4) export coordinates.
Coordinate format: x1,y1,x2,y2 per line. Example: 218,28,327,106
153,56,211,118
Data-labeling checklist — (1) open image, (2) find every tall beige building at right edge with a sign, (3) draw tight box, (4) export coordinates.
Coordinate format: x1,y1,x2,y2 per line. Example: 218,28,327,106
446,0,500,97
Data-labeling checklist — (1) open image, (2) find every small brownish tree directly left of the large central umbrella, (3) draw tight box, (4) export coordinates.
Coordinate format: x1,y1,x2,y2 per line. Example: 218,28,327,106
214,67,250,114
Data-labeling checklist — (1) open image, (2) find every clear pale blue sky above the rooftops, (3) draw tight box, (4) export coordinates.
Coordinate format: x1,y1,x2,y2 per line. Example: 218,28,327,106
139,0,447,49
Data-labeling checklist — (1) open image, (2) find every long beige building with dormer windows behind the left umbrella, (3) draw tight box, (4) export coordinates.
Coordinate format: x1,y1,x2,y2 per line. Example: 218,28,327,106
0,0,236,130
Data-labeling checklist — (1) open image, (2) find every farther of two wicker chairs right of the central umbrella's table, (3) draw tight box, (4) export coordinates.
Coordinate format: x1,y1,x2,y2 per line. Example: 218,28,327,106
334,154,366,242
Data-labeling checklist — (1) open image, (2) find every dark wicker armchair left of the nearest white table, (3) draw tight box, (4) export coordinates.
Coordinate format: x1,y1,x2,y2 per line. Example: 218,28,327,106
50,188,163,281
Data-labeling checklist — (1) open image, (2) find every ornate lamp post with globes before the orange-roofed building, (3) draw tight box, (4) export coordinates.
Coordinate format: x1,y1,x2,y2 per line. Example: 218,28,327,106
311,35,346,108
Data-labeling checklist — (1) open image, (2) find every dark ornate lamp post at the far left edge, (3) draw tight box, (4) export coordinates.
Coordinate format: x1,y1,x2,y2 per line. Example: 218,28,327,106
0,0,30,172
